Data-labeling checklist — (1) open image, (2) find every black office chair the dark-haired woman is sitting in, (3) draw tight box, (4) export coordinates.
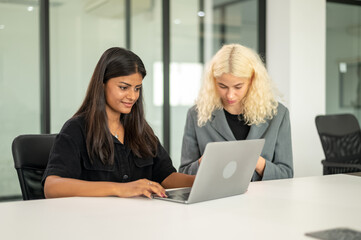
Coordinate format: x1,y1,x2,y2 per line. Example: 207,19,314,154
12,134,56,200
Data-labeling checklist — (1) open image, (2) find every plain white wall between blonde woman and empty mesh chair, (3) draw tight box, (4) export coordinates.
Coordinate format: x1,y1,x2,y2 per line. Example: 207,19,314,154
266,0,326,177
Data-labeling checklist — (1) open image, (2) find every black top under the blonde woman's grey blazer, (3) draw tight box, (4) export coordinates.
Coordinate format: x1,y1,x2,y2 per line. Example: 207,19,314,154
224,109,251,140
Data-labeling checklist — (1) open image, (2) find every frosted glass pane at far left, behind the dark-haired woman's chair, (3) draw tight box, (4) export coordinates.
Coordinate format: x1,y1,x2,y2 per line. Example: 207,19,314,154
0,1,40,198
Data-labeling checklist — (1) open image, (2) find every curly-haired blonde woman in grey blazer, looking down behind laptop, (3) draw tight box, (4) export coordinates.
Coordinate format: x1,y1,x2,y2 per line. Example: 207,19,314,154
179,44,293,181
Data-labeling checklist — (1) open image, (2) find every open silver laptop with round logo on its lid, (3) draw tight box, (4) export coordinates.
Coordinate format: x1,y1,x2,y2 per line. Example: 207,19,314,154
153,139,264,203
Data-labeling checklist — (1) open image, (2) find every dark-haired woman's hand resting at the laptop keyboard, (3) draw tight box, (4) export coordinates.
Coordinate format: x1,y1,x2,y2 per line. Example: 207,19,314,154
117,178,167,198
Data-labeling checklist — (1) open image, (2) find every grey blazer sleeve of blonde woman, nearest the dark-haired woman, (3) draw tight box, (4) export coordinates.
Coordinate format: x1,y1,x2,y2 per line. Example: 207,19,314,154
179,107,201,175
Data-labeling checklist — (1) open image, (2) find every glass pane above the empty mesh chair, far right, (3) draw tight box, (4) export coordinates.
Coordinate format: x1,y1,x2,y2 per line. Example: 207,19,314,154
326,1,361,120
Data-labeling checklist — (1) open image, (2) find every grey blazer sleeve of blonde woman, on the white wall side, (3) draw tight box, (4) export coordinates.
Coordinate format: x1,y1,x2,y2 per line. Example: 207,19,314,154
262,110,293,180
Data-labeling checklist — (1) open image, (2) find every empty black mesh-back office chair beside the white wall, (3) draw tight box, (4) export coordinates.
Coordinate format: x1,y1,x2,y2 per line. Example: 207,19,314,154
315,114,361,175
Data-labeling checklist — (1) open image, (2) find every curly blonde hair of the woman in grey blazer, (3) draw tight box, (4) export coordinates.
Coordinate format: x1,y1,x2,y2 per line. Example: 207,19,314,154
196,44,278,127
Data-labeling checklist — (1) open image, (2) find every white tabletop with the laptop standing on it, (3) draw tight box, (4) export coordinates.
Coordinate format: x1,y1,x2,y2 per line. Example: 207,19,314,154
0,175,361,240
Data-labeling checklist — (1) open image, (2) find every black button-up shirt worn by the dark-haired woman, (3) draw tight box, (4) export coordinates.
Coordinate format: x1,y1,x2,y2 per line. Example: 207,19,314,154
42,117,176,184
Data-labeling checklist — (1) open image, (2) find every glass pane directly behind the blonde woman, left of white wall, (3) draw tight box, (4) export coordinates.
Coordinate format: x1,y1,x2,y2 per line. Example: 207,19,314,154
170,0,258,168
